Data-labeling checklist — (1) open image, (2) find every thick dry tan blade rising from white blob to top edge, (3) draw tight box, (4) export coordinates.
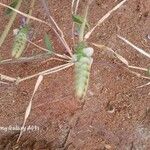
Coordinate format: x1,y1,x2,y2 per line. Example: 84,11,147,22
84,0,127,39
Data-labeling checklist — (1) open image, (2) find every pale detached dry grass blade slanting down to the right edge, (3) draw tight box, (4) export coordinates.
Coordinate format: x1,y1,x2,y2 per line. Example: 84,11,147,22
117,35,150,58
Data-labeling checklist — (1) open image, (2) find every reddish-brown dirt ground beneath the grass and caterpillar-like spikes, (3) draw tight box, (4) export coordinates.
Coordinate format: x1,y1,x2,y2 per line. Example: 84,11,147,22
0,0,150,150
